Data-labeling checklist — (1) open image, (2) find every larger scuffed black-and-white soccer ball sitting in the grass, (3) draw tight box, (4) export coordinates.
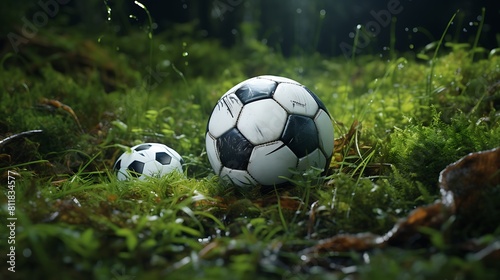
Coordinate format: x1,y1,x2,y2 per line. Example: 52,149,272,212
206,76,334,187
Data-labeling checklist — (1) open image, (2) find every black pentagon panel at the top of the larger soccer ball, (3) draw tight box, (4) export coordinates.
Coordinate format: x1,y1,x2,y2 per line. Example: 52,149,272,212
235,79,278,104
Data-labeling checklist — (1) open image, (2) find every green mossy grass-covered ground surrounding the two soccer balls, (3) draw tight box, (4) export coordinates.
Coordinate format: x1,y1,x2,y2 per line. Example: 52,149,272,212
0,17,500,279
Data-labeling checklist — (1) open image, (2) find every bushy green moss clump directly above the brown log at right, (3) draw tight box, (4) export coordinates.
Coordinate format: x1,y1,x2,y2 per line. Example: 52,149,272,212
389,111,500,199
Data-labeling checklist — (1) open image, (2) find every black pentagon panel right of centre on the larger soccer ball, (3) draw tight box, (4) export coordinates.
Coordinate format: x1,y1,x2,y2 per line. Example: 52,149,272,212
281,115,319,158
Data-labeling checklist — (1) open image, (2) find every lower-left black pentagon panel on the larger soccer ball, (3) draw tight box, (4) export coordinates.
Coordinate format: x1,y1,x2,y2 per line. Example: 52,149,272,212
217,128,253,170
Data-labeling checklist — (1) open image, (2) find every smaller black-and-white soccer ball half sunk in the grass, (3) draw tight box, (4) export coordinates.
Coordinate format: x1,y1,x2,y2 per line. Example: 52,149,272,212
113,143,184,181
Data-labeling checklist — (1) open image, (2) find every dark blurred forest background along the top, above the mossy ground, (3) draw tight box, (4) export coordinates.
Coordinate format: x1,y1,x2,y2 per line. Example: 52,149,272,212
0,0,500,56
